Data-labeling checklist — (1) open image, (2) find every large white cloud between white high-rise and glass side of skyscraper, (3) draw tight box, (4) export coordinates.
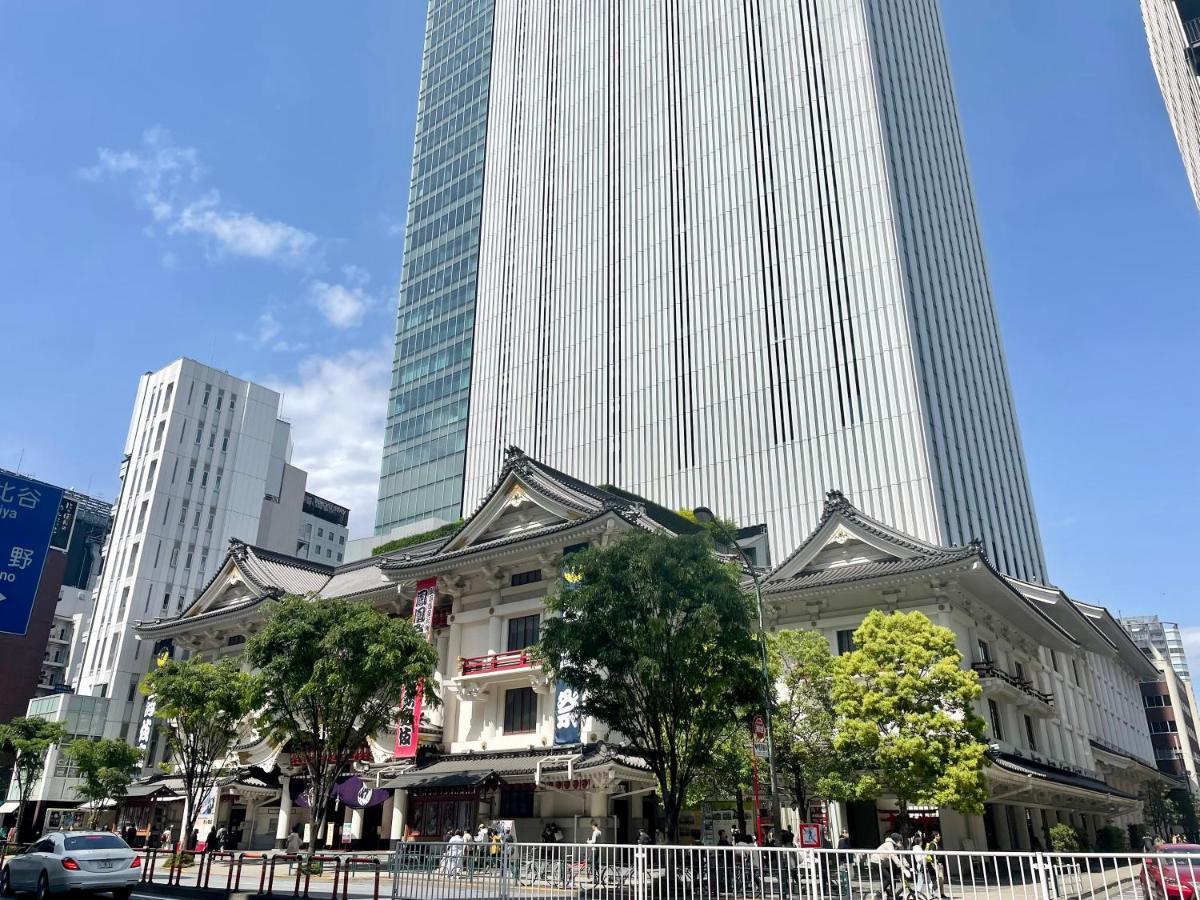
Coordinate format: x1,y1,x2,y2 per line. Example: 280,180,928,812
265,344,391,536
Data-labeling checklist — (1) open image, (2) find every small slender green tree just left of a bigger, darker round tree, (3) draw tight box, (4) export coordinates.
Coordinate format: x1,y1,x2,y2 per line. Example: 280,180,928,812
142,656,257,847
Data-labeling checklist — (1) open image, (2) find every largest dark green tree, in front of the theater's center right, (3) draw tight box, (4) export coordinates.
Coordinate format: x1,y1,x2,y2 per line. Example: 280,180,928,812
540,530,761,840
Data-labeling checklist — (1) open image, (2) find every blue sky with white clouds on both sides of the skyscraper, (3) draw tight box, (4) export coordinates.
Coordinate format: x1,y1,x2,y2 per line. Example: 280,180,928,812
0,7,1200,644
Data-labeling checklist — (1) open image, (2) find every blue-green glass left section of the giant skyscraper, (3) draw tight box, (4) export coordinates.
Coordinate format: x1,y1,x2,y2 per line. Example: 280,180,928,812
376,0,494,534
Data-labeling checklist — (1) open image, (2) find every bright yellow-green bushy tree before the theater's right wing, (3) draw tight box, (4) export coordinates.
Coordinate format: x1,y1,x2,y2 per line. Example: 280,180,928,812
833,610,988,821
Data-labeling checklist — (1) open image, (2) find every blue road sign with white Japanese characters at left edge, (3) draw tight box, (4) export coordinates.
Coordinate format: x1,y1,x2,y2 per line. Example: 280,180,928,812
0,475,62,635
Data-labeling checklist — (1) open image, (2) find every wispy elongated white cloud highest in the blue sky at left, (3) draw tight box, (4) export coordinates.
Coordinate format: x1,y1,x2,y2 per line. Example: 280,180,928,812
79,126,318,264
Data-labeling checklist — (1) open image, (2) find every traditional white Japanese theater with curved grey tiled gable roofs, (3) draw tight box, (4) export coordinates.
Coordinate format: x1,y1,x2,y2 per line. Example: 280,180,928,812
138,449,1163,850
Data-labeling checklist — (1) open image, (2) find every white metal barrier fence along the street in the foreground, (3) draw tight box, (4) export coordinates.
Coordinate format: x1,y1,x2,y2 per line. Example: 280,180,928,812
390,842,1200,900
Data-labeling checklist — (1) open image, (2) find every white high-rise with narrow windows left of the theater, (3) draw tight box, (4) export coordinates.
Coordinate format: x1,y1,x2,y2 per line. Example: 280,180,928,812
78,359,305,764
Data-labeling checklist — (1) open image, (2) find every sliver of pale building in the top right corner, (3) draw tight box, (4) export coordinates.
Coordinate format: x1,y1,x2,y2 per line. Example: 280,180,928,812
1141,0,1200,208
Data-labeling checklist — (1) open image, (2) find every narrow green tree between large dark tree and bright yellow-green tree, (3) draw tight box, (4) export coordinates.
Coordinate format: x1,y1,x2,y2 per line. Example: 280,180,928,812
767,630,862,820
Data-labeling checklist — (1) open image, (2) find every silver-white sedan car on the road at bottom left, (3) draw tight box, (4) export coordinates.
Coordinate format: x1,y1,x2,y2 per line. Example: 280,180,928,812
0,832,142,900
